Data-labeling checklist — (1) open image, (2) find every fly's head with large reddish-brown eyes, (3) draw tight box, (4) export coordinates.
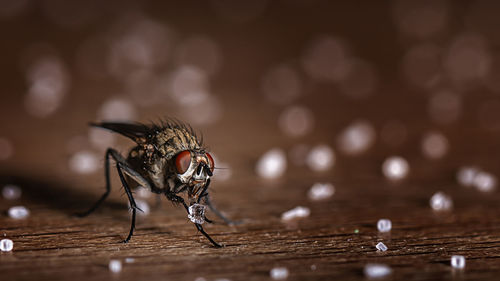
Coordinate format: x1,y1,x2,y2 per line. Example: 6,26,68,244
175,150,215,197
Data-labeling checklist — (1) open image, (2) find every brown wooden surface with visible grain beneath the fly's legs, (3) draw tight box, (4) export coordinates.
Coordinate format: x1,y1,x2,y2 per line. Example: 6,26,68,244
0,149,500,280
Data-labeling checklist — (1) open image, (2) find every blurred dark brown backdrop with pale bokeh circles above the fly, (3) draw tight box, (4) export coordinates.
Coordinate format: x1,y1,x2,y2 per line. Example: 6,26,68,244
1,1,500,175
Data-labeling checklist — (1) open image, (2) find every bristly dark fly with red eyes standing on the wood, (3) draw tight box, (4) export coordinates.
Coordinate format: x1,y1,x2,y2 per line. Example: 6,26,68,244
79,120,233,248
